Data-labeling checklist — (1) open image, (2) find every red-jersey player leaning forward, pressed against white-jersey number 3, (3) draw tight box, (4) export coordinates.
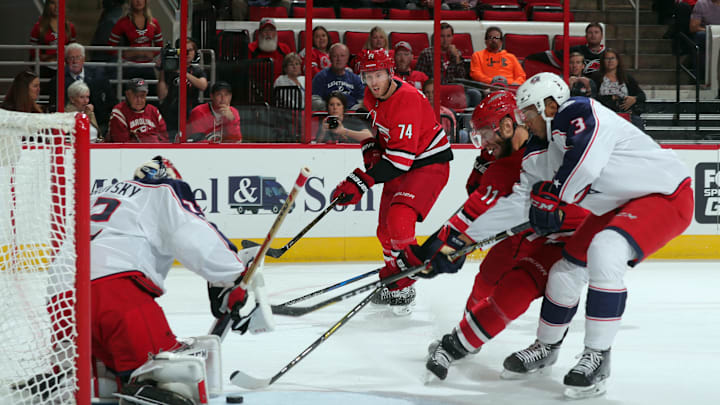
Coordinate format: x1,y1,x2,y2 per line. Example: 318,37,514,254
416,91,587,379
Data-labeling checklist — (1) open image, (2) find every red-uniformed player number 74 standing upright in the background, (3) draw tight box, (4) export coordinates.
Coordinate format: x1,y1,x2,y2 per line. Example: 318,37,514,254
332,49,453,314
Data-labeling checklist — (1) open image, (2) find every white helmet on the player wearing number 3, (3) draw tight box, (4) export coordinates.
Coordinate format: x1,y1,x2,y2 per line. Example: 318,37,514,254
515,72,570,121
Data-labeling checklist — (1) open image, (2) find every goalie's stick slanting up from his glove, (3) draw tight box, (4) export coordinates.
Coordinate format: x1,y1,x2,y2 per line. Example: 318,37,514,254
210,167,310,340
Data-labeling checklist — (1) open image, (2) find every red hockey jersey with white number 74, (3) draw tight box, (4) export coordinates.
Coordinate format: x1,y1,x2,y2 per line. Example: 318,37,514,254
363,79,453,172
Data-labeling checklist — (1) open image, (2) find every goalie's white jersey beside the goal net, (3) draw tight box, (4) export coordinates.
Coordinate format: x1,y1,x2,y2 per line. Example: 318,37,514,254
90,179,245,291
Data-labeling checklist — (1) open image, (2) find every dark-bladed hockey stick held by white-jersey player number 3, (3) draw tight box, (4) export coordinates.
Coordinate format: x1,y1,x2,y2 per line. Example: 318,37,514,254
272,222,530,316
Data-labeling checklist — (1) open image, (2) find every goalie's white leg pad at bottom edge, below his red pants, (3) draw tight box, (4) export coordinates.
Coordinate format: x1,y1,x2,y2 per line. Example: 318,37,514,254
126,352,208,405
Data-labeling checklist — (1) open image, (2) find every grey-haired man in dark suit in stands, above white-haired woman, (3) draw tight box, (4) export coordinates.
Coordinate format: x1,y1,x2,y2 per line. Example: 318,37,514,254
50,42,117,128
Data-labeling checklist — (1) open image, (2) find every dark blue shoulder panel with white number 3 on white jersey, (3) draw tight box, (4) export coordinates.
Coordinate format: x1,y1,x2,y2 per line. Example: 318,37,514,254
552,97,597,197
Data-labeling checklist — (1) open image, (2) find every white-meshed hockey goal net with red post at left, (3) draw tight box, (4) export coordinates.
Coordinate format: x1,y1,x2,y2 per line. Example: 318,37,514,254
0,110,90,404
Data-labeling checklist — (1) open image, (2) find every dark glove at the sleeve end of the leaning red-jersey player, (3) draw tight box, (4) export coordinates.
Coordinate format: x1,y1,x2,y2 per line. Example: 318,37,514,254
418,225,467,278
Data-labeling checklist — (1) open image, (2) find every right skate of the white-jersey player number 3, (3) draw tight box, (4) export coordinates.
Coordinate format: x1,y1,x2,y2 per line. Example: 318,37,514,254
564,347,610,399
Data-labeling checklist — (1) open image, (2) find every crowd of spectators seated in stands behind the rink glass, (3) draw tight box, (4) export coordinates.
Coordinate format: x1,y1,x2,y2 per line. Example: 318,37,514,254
8,0,696,142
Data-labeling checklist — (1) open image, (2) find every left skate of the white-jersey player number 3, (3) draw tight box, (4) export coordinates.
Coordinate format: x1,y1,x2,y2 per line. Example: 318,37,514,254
500,340,562,380
